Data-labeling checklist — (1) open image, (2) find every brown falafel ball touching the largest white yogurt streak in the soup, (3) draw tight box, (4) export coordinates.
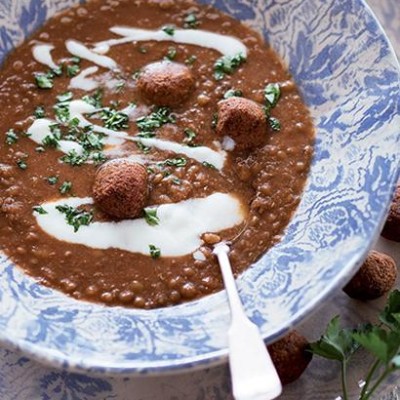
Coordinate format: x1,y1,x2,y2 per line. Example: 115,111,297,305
93,158,149,219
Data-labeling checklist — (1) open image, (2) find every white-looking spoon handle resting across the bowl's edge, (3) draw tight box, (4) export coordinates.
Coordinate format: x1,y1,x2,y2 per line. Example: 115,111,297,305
213,242,282,400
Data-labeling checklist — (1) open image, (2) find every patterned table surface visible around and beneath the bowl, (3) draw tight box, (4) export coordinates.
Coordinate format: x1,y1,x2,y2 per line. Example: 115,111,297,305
0,0,400,400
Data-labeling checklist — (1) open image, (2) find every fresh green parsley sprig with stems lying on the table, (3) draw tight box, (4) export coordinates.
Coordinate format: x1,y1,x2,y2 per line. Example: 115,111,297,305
310,290,400,400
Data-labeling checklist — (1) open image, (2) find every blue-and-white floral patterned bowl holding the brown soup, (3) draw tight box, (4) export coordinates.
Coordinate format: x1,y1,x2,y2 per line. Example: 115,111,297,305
0,0,400,375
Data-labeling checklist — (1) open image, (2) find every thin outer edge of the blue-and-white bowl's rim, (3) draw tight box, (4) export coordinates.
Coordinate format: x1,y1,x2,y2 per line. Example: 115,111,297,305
0,0,400,376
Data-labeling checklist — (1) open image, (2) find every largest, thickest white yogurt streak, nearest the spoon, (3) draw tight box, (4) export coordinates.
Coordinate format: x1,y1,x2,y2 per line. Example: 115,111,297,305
34,193,245,257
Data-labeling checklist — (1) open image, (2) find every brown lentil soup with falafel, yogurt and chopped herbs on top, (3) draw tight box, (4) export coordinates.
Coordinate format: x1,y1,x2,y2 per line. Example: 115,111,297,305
0,0,314,308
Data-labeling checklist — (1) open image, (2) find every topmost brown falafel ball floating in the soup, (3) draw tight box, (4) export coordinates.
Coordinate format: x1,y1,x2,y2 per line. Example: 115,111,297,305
136,61,195,107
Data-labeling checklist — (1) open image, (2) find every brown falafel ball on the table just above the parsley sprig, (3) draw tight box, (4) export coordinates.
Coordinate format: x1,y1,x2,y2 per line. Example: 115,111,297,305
343,250,397,300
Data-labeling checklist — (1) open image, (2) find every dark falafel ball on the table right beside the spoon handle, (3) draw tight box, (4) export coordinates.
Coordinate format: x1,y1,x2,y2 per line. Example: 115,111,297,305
268,331,312,385
